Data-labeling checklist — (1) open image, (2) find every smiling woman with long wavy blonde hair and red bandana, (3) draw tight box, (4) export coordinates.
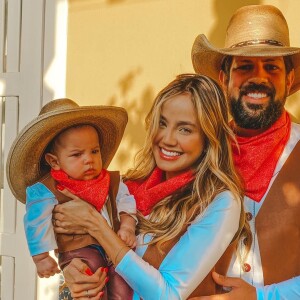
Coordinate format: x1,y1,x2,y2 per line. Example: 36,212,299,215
54,74,251,299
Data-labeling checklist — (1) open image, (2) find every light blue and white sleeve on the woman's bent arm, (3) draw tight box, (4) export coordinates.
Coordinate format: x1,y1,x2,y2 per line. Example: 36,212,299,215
116,192,240,299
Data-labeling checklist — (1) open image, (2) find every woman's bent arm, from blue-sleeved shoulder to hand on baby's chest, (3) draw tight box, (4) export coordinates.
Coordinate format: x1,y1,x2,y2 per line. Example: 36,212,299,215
55,192,240,299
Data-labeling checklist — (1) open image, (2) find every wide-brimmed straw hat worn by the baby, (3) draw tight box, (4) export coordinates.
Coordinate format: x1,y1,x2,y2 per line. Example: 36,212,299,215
6,99,128,203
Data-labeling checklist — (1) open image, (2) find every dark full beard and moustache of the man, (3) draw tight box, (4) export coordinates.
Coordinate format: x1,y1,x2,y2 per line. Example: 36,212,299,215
228,84,287,129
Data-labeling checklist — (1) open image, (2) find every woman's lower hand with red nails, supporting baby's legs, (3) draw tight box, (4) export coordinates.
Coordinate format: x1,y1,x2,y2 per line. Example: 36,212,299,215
63,258,108,300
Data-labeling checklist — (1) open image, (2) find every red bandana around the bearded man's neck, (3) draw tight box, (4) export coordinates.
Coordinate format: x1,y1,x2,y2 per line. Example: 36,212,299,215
232,111,291,202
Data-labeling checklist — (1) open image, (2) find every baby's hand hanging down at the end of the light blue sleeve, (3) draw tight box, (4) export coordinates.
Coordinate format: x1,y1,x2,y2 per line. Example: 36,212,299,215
32,253,60,278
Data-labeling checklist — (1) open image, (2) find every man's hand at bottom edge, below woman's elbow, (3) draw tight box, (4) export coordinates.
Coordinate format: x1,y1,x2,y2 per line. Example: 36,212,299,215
190,272,256,300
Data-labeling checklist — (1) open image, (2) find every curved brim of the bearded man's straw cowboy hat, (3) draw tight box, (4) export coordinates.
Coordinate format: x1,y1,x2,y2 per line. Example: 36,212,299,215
192,34,300,95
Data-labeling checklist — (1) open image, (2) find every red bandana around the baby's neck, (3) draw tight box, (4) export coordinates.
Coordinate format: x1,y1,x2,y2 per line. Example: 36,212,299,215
51,169,110,211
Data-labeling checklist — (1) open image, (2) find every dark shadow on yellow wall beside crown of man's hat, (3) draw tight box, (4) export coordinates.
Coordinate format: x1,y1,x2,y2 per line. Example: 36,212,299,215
208,0,262,47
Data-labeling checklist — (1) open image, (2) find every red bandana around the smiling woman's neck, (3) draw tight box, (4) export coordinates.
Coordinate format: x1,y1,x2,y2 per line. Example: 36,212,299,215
125,168,194,216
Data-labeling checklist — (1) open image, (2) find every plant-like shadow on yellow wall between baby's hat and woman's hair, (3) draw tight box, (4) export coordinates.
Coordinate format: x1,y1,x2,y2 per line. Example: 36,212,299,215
108,68,155,172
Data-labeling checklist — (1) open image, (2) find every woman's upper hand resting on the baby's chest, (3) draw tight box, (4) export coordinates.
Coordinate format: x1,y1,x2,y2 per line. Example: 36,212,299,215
53,189,100,234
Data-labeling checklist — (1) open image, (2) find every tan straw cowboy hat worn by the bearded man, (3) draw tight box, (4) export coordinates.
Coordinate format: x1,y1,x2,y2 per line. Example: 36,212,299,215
192,5,300,94
